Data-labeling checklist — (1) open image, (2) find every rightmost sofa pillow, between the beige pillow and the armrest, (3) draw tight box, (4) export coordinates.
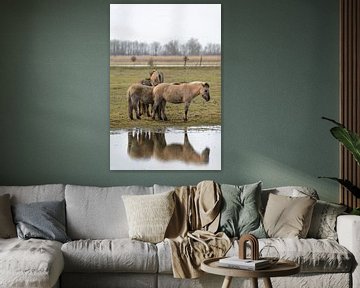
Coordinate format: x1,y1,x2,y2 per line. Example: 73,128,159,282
308,200,346,240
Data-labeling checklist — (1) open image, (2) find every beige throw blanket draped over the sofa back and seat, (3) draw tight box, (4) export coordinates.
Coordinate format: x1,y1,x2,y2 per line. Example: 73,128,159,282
165,181,231,278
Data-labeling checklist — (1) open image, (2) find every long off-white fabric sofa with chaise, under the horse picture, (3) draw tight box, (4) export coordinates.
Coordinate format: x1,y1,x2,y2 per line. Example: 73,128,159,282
0,184,360,288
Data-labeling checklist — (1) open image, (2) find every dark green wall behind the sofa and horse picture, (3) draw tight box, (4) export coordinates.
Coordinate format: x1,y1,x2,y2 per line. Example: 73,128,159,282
0,0,339,201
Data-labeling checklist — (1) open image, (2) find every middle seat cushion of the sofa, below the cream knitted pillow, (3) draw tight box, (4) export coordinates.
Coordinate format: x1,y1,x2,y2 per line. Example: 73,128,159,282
61,238,158,273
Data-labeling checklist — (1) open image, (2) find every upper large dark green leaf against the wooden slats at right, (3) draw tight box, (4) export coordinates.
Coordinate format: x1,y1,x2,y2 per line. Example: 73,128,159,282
323,117,360,165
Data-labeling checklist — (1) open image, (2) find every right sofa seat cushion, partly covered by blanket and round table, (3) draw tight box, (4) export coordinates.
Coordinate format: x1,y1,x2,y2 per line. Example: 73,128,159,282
157,238,355,274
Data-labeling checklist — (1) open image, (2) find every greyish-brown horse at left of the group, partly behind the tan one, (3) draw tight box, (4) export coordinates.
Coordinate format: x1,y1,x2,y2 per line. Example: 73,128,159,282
126,83,154,120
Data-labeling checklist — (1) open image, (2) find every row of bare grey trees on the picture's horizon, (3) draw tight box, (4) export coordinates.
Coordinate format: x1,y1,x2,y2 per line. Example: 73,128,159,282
110,38,221,56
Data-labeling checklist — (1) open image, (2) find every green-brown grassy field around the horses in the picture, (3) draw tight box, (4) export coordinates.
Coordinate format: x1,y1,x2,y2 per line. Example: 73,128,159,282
110,66,221,129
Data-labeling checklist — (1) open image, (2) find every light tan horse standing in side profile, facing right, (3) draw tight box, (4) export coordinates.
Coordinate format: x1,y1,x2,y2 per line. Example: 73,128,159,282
152,81,210,121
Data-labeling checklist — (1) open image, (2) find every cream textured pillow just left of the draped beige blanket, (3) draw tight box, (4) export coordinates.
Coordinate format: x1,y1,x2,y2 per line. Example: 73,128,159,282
122,191,175,243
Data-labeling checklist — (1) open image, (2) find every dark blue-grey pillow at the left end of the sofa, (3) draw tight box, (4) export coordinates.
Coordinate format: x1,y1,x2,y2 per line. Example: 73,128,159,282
13,201,70,243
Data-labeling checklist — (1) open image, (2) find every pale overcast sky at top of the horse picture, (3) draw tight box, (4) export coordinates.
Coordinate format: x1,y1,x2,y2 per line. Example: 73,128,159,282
110,4,221,46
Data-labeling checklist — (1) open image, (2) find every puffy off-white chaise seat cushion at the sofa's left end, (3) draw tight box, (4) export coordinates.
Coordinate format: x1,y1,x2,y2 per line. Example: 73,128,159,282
0,238,64,288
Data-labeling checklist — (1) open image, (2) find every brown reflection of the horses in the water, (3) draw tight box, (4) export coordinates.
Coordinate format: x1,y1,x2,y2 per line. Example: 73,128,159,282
127,131,210,164
